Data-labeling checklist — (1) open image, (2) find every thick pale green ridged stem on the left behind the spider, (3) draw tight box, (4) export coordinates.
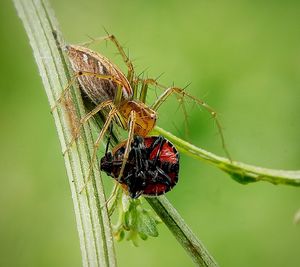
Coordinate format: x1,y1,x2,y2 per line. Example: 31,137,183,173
14,0,116,267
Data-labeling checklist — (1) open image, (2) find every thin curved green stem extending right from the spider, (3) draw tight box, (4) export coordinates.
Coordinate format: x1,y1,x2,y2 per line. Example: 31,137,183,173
153,126,300,186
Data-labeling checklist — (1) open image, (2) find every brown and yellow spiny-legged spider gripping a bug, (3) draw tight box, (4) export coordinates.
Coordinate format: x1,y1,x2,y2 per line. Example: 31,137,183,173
58,35,227,193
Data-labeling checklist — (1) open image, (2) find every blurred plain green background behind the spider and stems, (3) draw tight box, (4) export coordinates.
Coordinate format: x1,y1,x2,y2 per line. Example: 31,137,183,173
0,0,300,267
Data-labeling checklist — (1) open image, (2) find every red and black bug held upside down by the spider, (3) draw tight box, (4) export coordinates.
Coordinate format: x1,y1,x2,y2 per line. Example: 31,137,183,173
100,135,179,198
